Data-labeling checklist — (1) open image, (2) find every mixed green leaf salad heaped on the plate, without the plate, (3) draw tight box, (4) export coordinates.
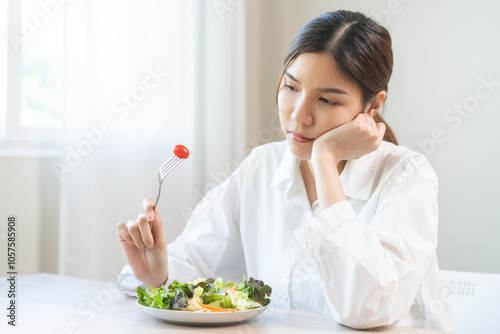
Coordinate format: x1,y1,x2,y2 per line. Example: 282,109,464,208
136,277,272,312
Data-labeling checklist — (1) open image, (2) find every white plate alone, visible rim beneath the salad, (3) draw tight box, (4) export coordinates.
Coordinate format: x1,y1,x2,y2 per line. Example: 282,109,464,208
136,301,269,325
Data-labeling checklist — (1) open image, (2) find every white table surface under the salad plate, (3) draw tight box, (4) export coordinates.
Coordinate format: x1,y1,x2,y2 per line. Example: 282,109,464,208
0,274,446,334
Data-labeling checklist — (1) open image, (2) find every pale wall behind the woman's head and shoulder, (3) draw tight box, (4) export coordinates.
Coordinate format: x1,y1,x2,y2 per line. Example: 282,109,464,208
255,0,500,273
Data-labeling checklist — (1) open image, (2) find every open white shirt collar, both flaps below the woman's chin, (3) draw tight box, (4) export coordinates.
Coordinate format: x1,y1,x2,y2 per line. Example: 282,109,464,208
270,142,383,200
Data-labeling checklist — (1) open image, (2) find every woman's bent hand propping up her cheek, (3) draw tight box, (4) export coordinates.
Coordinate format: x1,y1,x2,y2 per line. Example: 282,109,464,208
311,113,385,163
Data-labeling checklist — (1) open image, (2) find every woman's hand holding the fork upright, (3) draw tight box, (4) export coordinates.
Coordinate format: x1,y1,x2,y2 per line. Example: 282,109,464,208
116,198,168,287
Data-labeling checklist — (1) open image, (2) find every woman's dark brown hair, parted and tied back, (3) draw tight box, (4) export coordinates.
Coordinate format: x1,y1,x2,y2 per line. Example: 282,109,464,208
276,10,398,145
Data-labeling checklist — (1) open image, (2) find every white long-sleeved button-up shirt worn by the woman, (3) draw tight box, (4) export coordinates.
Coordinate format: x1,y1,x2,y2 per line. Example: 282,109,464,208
120,141,453,331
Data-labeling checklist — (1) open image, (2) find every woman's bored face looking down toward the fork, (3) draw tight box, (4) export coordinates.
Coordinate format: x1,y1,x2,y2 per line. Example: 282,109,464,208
278,53,362,160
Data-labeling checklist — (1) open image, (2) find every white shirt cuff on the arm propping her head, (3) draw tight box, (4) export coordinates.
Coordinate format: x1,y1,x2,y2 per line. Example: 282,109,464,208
294,201,357,248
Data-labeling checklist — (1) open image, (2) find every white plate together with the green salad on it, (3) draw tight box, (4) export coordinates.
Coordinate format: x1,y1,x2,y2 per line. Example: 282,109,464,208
136,277,272,325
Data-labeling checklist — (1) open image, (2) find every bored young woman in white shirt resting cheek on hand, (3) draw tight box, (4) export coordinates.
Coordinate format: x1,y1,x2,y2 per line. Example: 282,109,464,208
117,11,452,331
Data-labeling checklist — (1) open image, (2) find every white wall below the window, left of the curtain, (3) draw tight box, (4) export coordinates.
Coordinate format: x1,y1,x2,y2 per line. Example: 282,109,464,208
0,157,59,275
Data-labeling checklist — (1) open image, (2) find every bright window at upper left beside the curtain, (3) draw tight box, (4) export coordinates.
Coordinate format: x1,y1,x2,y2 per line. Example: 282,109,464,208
0,0,63,154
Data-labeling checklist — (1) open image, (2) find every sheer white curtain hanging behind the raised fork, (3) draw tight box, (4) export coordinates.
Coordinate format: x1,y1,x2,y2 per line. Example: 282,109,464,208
58,0,246,280
